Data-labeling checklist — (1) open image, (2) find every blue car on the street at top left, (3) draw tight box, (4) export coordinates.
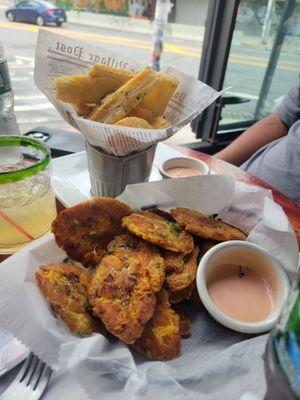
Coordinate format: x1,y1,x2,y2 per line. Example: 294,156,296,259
5,0,67,26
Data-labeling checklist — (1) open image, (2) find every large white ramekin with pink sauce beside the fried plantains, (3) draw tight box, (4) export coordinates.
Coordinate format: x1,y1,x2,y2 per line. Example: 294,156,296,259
197,240,290,334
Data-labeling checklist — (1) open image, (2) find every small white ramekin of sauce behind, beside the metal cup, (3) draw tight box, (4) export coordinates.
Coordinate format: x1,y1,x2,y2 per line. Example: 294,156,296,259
159,157,210,179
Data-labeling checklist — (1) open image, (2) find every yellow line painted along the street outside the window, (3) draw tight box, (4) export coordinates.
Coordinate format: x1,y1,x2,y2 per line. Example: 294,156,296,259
0,22,300,72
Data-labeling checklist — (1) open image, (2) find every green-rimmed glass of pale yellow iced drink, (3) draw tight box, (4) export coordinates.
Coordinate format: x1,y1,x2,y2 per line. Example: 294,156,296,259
0,136,56,254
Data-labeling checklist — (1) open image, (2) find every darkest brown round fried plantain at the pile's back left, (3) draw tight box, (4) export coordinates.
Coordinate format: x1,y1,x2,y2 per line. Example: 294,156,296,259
52,197,131,266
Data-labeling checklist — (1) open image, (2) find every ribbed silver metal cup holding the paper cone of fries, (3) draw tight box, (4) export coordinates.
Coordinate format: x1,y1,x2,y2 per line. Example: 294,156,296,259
86,142,156,197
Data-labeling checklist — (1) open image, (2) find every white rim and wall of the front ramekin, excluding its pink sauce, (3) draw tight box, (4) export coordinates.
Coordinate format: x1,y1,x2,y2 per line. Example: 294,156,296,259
196,240,290,333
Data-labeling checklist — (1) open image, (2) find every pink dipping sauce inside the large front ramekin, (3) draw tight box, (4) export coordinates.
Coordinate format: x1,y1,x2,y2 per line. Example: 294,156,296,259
207,264,274,322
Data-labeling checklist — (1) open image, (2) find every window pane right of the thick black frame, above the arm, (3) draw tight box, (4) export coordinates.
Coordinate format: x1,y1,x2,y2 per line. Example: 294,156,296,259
219,0,300,126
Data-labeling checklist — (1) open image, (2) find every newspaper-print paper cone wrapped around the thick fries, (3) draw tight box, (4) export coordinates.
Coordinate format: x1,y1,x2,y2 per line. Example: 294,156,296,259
34,29,222,156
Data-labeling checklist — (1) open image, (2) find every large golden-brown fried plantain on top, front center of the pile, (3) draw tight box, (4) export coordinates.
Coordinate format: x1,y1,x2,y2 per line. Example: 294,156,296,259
89,234,165,344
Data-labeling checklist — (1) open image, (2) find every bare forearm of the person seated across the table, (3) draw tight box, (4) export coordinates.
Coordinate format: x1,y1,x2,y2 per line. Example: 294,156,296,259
214,113,288,166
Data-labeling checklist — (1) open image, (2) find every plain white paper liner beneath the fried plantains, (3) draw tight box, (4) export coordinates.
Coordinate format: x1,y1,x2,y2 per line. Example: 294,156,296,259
0,175,299,400
